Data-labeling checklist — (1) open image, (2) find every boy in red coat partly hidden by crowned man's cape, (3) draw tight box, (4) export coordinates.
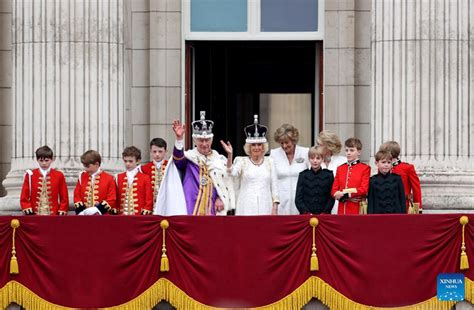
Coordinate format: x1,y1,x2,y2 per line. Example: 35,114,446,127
141,138,168,206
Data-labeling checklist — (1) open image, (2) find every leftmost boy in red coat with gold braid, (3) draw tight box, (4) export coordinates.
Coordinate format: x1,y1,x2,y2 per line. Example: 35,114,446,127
20,145,69,215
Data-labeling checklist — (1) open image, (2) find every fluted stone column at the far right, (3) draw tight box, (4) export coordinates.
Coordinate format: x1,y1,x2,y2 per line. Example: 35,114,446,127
371,0,474,212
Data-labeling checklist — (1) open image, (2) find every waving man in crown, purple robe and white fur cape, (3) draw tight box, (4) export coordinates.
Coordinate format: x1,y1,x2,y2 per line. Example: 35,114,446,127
155,111,235,215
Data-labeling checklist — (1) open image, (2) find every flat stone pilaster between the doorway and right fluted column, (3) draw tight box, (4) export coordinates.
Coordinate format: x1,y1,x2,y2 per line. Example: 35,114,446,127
324,0,371,161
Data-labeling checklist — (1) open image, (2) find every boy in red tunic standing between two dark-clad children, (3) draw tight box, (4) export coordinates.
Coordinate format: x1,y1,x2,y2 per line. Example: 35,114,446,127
331,138,370,214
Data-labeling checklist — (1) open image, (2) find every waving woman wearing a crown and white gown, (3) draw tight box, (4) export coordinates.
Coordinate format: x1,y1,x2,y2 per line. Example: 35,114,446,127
221,115,280,215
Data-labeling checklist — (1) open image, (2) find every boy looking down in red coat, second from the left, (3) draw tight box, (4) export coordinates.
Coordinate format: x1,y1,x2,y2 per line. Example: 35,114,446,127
74,150,118,215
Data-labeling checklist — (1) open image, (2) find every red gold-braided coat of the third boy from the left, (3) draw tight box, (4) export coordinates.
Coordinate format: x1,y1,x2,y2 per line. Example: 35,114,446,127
117,172,153,215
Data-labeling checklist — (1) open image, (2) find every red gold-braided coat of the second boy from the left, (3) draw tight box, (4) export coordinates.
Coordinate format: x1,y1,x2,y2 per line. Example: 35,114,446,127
74,171,117,213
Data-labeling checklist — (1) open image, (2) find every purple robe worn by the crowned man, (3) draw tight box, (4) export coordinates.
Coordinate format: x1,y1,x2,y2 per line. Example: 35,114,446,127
173,147,218,215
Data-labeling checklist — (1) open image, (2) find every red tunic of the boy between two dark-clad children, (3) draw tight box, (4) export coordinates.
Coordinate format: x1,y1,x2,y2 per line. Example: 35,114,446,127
331,160,370,214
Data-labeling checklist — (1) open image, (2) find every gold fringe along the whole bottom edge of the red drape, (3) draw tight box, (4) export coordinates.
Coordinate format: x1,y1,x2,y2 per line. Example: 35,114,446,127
0,276,462,310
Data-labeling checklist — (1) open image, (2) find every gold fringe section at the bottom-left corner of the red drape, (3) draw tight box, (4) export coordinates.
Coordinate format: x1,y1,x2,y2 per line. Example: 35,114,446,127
0,281,72,310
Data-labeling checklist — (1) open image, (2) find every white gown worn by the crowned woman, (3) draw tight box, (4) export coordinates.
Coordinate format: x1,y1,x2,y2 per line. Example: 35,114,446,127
229,156,279,215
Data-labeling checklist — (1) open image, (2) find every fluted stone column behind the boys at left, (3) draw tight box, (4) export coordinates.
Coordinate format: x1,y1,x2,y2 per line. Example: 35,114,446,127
0,0,125,213
